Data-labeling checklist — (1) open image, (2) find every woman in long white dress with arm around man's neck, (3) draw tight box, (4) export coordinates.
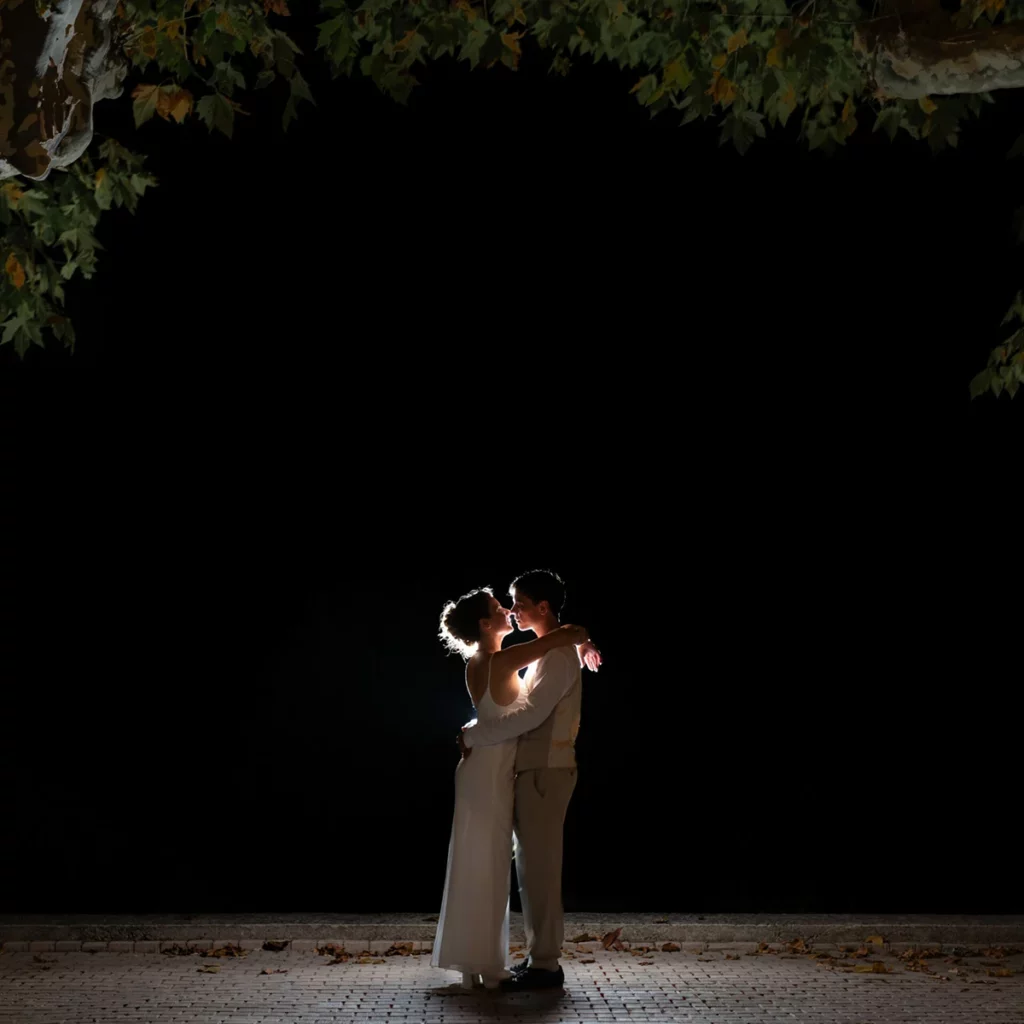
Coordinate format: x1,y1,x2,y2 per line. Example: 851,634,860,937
430,587,587,989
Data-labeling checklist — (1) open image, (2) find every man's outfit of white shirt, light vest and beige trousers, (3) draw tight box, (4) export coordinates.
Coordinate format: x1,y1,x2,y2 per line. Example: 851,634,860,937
463,646,583,971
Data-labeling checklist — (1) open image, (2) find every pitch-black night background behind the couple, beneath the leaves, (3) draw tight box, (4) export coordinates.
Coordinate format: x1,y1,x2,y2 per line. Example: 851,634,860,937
0,9,1024,912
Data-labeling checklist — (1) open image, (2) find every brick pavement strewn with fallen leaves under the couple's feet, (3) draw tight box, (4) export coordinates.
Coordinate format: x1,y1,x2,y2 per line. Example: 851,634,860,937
0,943,1024,1024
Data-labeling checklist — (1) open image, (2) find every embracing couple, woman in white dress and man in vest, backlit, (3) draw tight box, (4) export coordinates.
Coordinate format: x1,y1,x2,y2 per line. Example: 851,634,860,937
431,571,601,991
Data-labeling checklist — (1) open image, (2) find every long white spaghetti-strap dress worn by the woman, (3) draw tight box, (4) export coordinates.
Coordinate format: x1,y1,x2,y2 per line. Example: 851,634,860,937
430,660,531,987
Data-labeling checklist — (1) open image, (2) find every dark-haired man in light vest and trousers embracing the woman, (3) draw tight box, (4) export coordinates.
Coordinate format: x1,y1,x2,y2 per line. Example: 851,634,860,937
459,571,601,991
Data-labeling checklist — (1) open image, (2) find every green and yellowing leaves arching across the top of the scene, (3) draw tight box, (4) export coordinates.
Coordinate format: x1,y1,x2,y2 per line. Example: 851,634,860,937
0,0,1024,395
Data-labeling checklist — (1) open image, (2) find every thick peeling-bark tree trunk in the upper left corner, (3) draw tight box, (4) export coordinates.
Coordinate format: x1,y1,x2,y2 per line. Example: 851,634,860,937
0,0,127,181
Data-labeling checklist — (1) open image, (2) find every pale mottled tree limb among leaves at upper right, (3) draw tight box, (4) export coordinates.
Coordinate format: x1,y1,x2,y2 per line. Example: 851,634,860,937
854,12,1024,99
